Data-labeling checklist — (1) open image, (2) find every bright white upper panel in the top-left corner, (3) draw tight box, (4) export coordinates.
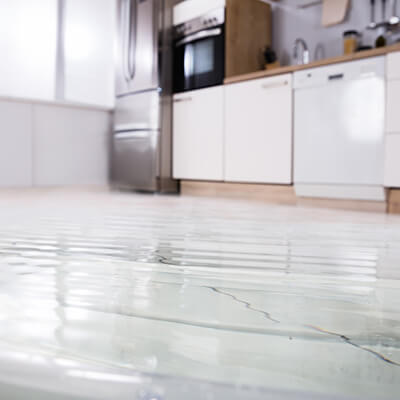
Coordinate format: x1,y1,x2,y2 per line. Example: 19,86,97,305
0,0,58,100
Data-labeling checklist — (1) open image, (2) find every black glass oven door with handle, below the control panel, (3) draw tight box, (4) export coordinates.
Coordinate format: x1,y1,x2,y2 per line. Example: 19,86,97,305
174,25,225,93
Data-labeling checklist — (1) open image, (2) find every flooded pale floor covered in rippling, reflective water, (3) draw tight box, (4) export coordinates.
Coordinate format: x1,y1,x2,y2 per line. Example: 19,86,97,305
0,191,400,400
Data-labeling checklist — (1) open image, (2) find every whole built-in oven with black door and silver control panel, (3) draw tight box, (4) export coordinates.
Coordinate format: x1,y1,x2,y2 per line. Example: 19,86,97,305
174,7,225,93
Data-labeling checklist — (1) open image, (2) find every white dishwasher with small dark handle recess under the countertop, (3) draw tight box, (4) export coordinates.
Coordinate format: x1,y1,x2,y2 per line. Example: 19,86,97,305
294,57,385,201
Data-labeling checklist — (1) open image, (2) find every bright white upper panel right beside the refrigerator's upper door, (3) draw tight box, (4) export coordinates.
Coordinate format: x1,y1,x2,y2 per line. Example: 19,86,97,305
64,0,116,107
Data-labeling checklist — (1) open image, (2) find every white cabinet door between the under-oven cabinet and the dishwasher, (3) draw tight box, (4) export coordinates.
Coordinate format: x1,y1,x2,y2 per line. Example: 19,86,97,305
225,75,292,184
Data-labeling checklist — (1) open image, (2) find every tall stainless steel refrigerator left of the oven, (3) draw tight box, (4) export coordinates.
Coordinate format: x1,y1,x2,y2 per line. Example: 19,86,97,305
111,0,177,192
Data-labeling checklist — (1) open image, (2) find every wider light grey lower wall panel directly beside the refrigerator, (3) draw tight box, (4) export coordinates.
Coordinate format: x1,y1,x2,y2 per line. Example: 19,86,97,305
32,104,111,186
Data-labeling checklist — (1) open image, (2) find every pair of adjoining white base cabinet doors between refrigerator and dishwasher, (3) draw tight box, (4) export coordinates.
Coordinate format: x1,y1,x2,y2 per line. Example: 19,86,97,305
173,74,293,184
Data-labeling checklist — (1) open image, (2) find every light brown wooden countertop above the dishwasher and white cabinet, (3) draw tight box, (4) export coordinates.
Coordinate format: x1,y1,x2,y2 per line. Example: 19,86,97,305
224,43,400,84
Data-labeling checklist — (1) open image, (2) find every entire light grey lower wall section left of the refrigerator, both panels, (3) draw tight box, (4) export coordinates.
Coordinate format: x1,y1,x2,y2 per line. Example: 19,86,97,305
0,100,111,188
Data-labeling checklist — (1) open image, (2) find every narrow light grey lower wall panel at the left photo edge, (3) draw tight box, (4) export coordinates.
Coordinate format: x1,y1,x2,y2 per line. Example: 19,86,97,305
0,101,32,187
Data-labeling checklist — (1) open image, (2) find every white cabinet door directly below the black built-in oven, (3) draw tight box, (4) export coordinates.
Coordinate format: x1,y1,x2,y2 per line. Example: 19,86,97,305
173,86,224,181
